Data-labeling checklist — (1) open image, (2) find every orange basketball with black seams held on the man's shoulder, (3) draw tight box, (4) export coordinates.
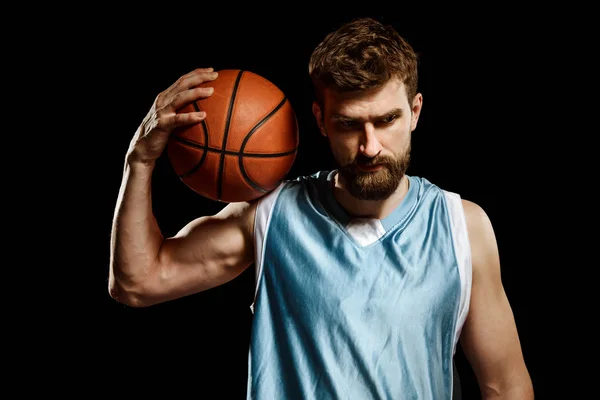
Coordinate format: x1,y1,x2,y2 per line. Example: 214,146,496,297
167,69,299,203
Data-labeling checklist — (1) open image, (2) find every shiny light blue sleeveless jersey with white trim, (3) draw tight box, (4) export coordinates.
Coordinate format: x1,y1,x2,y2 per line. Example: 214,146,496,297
247,171,471,400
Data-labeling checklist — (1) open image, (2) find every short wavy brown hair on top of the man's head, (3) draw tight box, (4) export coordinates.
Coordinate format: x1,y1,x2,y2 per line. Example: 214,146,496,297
308,18,418,106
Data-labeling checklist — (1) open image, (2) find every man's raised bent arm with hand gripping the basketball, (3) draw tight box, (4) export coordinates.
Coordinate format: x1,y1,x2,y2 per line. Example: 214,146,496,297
109,69,255,307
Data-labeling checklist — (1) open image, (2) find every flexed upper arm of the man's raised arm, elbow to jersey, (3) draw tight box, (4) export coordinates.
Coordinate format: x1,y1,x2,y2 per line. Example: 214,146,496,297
149,203,255,301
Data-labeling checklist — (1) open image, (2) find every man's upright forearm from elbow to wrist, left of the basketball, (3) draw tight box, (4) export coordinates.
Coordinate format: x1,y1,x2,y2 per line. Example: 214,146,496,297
109,159,163,300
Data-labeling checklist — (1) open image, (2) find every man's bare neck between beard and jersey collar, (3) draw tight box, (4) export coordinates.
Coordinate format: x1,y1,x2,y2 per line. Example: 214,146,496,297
333,173,409,219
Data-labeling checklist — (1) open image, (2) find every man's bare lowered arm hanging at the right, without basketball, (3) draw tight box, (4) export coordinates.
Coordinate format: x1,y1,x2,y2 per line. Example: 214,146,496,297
460,200,534,400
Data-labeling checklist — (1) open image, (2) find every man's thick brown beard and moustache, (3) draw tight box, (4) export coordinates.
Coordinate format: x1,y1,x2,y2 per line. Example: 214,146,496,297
339,144,410,200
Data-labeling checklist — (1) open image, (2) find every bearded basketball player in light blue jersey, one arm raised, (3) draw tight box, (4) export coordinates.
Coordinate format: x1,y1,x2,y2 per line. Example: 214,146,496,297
109,19,533,400
